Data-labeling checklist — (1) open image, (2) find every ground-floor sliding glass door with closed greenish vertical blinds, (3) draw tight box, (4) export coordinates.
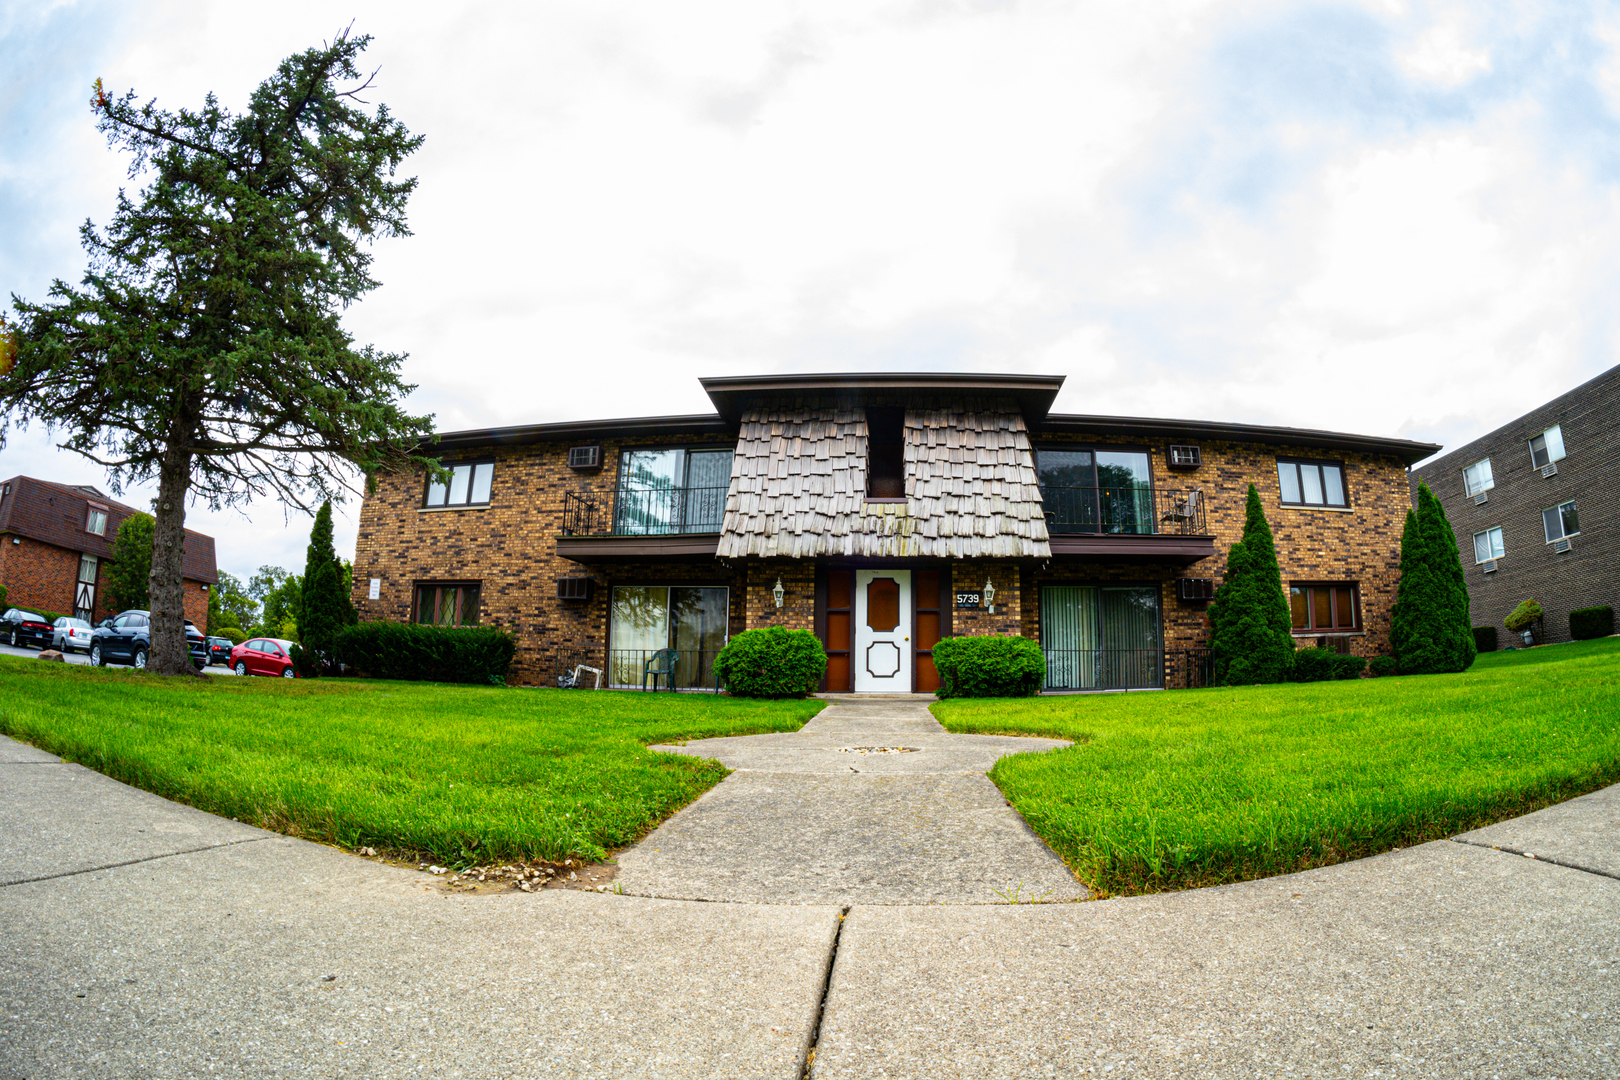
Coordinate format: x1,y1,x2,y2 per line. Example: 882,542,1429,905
1040,585,1165,690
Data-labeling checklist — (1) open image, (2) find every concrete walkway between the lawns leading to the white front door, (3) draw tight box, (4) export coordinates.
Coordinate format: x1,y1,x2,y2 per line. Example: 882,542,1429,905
619,696,1089,905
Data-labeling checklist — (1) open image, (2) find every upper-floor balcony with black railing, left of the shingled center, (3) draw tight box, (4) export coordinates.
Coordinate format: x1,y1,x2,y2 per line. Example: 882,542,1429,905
557,486,726,562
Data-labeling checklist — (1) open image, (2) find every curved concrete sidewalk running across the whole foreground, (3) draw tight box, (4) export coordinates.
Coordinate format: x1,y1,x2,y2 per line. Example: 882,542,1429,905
0,732,1620,1080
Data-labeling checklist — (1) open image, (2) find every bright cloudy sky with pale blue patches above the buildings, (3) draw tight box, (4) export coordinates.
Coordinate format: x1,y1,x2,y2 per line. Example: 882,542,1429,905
0,0,1620,575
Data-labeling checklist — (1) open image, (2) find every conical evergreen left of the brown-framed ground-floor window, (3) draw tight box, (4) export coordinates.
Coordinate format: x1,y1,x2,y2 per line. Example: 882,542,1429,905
1210,484,1294,685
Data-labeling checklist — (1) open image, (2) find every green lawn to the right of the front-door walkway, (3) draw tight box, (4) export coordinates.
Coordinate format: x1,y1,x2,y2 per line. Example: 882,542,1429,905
933,638,1620,894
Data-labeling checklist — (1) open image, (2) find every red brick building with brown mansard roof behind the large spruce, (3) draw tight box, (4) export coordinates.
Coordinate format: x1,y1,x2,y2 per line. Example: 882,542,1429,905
0,476,219,628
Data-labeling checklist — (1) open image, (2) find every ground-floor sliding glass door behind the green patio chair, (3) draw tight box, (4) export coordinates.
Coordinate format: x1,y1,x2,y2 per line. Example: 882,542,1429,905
608,585,731,688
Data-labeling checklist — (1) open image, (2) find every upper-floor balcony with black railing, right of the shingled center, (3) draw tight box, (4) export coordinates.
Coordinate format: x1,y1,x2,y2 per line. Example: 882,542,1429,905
1040,484,1215,563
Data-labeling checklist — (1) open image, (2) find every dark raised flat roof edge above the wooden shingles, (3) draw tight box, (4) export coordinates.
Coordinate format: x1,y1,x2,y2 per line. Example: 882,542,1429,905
698,371,1063,426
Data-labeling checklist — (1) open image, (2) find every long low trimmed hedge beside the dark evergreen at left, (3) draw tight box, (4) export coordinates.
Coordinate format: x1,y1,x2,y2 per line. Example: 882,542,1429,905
337,622,517,685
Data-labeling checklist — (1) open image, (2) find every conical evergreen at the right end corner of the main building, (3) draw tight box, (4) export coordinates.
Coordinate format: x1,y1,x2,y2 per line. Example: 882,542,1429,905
1390,483,1476,674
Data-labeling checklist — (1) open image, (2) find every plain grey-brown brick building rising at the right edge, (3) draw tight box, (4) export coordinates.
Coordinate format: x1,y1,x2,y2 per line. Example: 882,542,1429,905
1413,368,1620,644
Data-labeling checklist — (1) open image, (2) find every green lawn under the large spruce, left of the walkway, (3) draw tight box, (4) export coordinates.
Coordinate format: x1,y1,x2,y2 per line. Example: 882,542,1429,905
0,657,823,866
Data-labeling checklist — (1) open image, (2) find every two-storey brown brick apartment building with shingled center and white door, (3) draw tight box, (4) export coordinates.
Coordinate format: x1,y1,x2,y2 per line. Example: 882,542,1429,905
355,376,1439,691
